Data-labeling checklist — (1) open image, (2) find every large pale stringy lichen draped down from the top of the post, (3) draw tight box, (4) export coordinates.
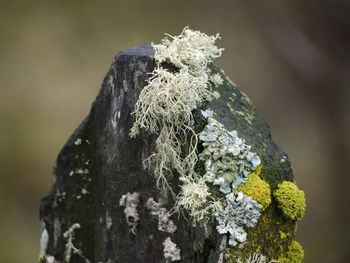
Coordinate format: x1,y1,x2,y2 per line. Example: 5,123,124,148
130,27,222,194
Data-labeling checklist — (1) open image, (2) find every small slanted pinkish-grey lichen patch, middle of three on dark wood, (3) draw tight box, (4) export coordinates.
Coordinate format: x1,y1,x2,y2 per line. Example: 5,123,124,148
146,197,177,233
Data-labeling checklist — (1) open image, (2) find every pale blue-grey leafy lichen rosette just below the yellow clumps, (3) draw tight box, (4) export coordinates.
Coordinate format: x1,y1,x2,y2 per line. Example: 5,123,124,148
216,192,261,246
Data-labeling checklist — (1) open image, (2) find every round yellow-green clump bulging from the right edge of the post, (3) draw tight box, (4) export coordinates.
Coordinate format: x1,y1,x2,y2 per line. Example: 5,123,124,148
274,181,306,220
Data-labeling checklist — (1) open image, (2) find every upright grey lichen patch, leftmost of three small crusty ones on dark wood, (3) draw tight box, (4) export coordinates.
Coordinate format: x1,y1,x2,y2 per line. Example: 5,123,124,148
119,192,140,234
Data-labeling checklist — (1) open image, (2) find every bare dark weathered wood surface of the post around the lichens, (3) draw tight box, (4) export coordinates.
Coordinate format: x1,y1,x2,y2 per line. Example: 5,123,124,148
40,45,294,263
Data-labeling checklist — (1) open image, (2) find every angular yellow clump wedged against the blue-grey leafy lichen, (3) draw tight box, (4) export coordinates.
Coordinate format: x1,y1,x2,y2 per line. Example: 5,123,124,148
237,165,271,211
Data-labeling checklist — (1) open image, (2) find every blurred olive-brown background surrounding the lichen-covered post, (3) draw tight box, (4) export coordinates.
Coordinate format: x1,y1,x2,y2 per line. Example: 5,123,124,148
0,0,350,263
